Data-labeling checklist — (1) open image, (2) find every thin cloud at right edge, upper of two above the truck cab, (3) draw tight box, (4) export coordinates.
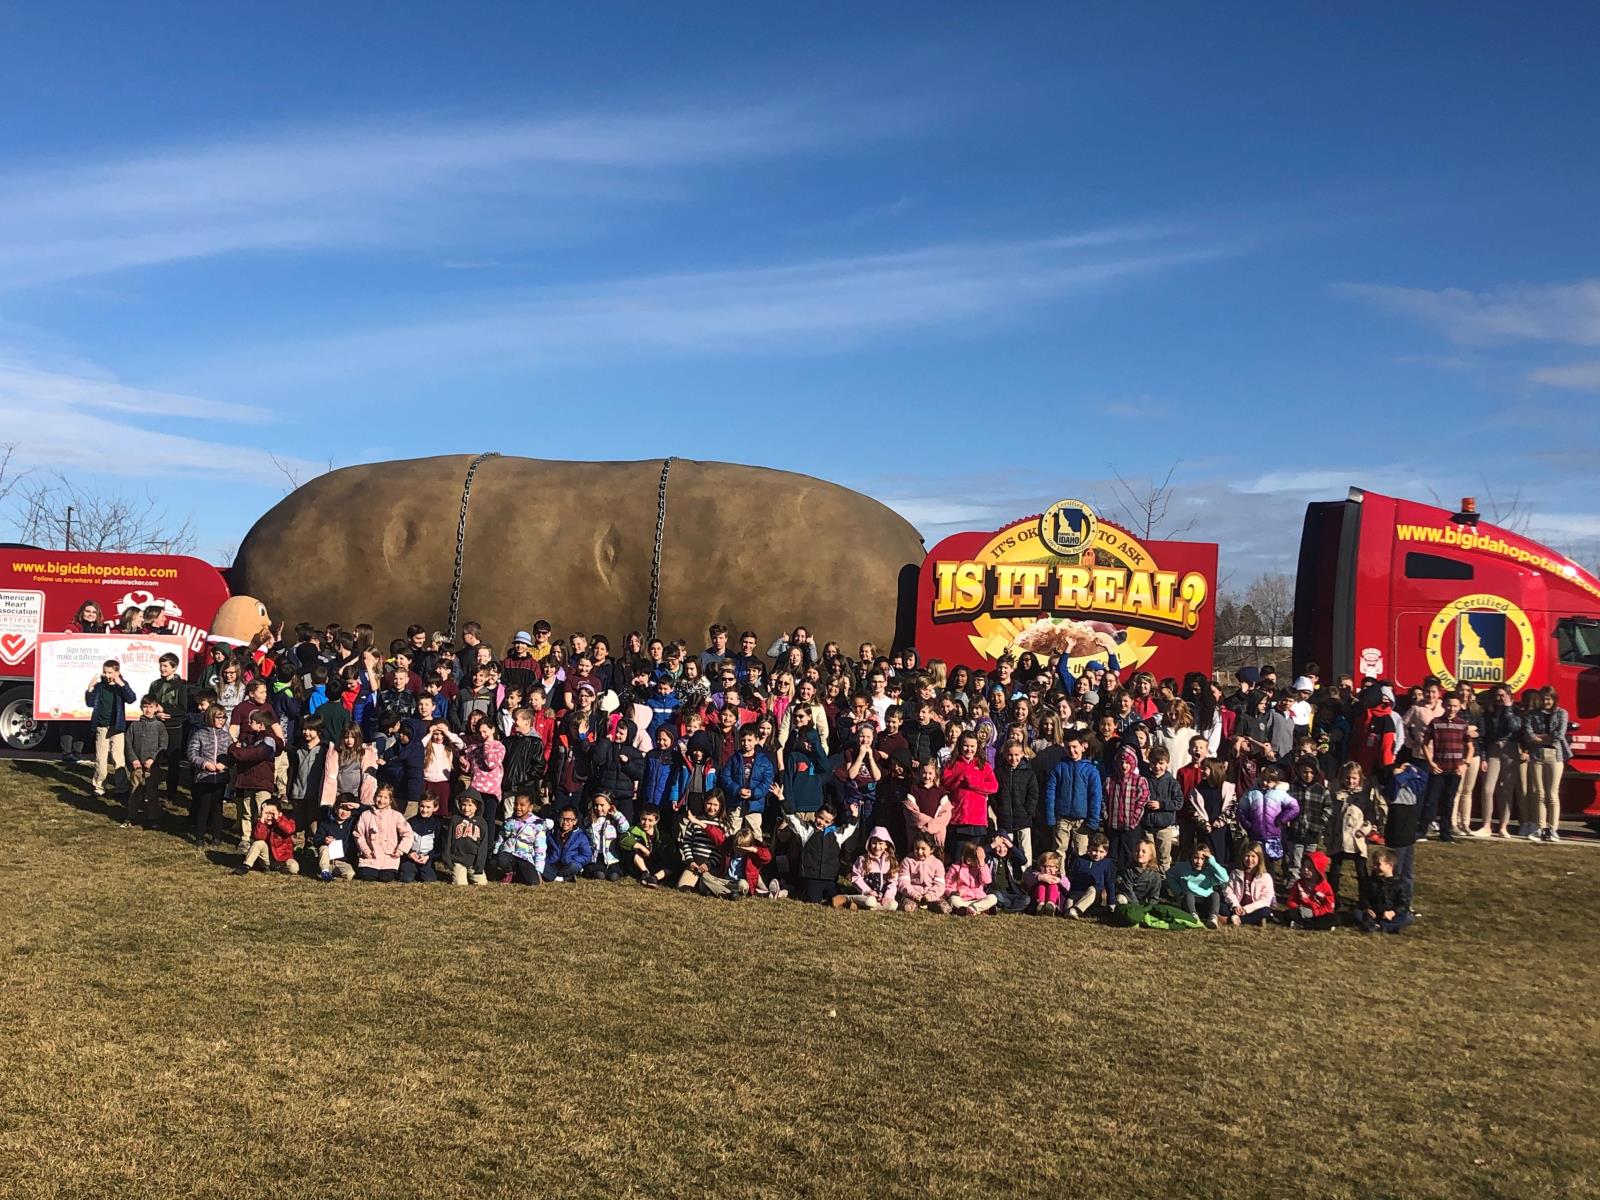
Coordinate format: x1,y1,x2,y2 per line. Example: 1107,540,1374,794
1338,278,1600,346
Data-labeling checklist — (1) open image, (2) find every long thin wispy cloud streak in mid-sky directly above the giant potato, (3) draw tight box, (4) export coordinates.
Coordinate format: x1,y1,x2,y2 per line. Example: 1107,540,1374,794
225,227,1232,374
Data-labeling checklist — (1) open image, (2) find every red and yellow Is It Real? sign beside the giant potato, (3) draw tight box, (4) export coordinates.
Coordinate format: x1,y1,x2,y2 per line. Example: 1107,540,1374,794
917,501,1216,677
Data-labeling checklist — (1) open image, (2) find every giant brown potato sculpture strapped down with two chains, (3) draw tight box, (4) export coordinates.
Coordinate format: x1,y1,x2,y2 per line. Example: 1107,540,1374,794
229,454,923,650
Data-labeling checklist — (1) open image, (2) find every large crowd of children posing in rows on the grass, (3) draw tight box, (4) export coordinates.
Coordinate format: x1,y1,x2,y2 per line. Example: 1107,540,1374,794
75,604,1570,933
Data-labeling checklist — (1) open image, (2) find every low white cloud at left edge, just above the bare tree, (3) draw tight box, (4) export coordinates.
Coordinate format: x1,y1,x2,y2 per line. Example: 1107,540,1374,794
0,350,312,482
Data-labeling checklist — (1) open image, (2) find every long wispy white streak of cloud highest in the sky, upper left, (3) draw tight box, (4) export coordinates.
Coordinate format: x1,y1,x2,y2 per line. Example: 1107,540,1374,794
0,102,915,288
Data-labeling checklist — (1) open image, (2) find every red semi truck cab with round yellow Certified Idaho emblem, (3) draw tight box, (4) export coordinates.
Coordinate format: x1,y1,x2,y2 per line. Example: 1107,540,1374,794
1294,488,1600,816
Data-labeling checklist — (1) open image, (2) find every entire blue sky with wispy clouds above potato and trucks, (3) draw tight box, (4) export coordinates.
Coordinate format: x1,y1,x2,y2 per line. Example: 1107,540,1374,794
0,3,1600,581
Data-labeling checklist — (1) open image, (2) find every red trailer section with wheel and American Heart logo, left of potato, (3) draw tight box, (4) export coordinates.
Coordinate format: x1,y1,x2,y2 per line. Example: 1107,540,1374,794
0,546,227,750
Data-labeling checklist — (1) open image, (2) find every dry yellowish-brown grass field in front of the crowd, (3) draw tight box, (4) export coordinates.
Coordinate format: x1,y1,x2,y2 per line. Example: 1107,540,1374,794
0,763,1600,1197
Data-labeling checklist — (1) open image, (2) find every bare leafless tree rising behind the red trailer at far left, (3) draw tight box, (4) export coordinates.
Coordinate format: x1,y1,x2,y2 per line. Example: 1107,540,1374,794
14,472,195,554
